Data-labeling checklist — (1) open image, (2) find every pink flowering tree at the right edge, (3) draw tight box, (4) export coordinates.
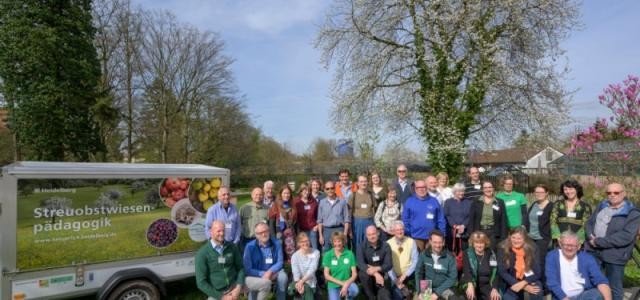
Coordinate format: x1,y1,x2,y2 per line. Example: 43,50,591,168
570,75,640,199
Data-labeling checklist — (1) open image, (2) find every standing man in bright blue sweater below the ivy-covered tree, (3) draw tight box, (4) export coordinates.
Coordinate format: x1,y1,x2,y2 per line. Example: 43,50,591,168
402,180,447,252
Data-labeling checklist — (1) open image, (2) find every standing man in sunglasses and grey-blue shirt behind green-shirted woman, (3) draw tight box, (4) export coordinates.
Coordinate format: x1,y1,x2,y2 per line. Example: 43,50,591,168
316,181,351,252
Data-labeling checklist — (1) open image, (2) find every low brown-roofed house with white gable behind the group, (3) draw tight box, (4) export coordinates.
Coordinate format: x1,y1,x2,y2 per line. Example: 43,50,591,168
465,147,564,173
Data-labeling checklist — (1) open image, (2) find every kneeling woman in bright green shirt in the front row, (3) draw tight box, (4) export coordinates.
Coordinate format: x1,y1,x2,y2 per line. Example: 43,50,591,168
322,232,359,300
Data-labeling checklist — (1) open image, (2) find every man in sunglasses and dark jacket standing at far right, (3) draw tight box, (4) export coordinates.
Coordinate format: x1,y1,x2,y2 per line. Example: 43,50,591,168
585,183,640,300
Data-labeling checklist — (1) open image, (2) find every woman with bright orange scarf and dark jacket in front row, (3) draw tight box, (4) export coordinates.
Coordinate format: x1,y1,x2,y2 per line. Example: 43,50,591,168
498,227,544,300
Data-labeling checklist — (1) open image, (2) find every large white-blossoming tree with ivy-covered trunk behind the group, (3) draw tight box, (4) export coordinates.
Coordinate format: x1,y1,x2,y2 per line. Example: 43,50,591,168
317,0,577,178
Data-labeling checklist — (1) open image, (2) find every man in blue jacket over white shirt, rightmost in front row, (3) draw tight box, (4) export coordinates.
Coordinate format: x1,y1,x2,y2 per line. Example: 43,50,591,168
545,231,611,300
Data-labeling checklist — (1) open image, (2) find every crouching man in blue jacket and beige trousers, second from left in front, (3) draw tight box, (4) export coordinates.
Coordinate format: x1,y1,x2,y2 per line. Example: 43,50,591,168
243,222,289,300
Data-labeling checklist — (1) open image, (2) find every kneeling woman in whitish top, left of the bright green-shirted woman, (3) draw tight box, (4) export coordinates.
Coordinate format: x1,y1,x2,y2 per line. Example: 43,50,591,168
287,232,320,300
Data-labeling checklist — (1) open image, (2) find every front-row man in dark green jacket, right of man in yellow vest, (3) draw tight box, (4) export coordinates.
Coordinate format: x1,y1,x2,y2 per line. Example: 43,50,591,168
415,230,458,300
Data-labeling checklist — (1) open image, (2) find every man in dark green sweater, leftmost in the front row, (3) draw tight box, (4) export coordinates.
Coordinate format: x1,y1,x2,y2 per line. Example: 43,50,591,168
196,221,245,300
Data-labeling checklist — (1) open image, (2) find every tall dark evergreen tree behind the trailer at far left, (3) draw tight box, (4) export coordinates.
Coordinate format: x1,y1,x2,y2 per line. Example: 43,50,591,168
0,0,104,160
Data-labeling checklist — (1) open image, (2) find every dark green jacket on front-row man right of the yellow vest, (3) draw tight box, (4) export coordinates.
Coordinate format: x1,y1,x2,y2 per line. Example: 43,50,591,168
415,248,458,296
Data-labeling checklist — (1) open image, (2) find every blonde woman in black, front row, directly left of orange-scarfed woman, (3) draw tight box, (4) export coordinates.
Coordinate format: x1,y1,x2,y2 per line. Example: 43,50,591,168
460,231,500,300
